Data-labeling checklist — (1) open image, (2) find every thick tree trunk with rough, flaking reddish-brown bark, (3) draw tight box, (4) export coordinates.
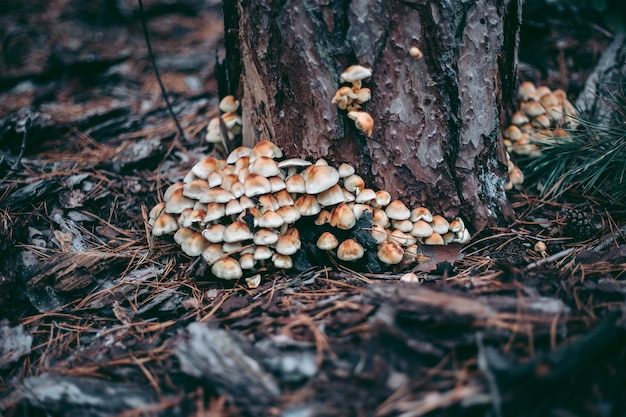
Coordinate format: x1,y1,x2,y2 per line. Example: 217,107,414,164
219,0,521,230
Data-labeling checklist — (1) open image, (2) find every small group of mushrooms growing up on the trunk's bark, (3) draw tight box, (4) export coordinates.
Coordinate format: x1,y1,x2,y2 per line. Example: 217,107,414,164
332,65,374,137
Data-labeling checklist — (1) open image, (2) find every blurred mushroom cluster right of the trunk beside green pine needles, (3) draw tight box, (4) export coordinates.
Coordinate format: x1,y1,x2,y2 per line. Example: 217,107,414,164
503,81,578,157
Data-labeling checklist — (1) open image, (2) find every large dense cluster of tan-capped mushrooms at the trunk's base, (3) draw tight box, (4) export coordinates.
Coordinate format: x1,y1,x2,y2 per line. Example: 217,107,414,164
149,141,470,287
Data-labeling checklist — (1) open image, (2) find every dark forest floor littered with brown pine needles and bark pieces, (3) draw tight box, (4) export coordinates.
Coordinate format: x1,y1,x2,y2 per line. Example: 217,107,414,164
0,0,626,417
